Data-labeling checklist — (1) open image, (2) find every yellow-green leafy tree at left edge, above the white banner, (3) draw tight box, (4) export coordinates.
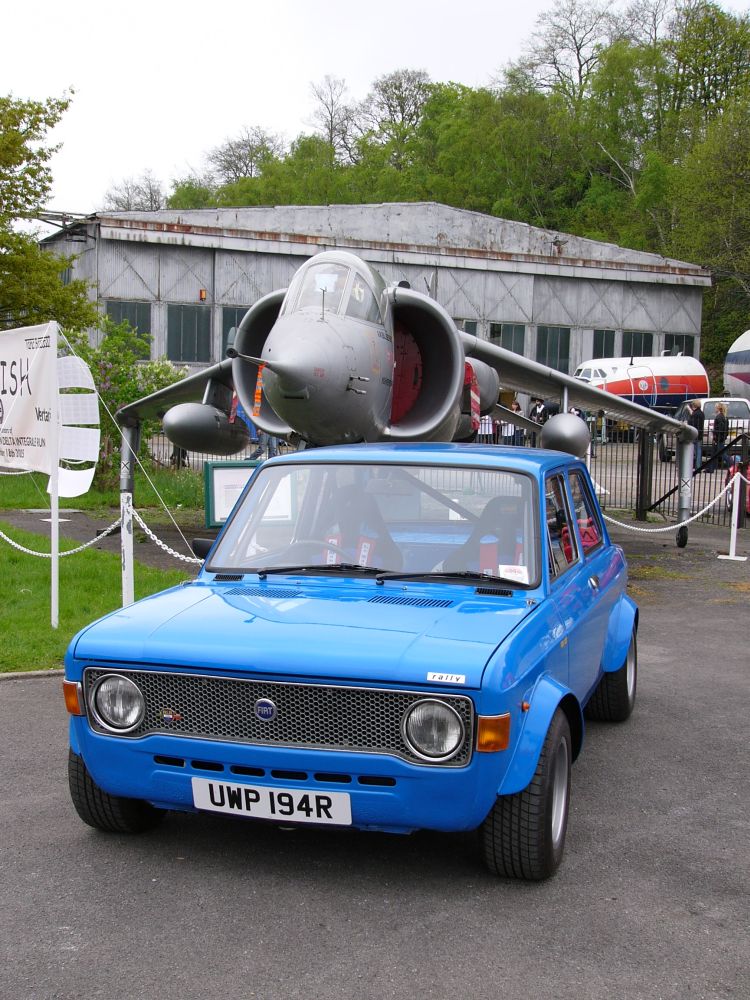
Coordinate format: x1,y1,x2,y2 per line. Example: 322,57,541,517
0,96,97,329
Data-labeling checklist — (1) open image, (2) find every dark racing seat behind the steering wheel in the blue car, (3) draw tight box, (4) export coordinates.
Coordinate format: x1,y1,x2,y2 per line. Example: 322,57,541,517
325,486,403,570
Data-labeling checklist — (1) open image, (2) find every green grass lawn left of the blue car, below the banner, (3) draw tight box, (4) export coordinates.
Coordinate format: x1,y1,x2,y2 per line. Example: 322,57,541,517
0,520,194,673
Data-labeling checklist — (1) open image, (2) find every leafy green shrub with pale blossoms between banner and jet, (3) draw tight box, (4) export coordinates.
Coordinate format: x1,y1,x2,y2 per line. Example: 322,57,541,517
68,316,186,484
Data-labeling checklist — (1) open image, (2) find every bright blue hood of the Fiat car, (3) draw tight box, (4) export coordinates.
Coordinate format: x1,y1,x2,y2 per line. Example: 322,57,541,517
71,578,533,687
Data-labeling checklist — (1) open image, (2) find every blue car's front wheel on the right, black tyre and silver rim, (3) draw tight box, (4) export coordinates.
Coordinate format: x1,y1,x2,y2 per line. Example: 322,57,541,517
479,708,573,882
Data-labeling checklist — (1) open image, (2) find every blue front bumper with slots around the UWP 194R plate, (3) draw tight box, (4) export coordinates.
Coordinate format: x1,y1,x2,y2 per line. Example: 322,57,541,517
70,717,512,833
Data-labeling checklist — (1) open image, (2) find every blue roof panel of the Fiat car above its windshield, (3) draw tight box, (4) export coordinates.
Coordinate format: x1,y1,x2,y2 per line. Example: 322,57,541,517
267,441,585,476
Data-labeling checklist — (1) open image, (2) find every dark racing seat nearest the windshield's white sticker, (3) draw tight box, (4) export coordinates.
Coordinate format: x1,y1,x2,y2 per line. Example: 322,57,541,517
442,497,523,573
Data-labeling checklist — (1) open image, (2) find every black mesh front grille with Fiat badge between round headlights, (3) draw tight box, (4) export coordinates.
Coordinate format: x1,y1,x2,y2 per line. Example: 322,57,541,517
84,668,474,767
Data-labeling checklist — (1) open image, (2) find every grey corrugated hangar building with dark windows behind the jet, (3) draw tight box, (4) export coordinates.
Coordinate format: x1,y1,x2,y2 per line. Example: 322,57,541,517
42,202,711,373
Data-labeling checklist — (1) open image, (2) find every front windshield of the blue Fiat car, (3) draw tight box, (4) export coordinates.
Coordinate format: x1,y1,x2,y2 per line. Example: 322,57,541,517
208,463,539,586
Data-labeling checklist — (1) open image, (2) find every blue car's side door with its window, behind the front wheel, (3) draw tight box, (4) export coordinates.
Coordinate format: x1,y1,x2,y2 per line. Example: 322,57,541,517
545,471,613,701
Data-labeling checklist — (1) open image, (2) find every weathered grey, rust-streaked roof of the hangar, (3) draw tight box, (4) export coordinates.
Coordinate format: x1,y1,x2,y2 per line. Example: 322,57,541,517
43,202,711,285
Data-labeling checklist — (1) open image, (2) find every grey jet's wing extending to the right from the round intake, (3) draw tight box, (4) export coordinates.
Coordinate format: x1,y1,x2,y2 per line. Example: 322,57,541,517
459,331,692,437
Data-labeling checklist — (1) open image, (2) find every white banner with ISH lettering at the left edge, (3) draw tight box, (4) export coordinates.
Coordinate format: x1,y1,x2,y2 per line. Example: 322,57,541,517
0,323,57,475
